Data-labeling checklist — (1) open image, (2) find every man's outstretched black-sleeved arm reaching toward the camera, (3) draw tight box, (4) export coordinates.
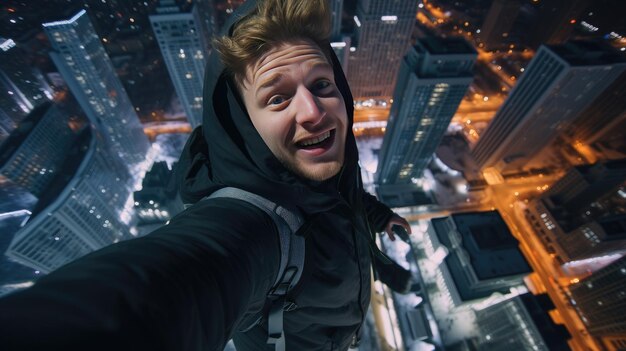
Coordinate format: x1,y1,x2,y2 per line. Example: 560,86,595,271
0,199,279,351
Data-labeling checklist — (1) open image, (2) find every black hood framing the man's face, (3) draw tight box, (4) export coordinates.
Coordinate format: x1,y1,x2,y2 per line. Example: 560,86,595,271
177,0,361,214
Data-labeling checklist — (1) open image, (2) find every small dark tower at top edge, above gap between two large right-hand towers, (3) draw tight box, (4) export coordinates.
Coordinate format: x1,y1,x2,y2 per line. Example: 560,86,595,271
478,0,522,50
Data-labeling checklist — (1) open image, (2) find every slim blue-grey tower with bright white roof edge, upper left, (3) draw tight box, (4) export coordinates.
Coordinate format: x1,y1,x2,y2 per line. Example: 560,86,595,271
43,10,150,174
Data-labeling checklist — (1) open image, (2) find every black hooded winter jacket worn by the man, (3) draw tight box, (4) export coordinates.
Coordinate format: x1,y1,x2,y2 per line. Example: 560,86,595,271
0,1,392,351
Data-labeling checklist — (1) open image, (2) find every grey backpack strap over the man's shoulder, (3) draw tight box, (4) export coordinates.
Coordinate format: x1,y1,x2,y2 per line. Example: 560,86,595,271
207,187,305,351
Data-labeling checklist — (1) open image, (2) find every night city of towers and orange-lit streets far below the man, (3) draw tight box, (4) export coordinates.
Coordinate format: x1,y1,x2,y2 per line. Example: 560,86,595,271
0,0,626,351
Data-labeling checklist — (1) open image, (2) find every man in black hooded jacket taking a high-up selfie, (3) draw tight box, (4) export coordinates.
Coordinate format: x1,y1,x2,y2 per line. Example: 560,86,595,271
0,0,410,351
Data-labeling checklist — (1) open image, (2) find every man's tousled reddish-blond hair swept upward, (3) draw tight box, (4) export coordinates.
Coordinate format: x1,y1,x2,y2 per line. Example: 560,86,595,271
213,0,331,86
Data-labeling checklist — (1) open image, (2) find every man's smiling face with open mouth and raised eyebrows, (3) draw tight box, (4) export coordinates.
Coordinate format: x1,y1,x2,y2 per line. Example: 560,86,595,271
241,40,348,181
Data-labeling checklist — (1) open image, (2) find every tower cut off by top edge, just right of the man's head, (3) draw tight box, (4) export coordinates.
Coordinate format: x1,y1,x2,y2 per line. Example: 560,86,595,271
348,0,417,100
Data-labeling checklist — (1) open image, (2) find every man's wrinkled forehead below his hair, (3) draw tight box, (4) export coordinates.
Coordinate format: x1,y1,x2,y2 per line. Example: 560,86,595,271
246,40,332,85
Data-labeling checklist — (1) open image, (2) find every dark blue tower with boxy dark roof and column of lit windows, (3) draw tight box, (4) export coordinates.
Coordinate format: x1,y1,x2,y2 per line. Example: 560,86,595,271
376,37,477,205
